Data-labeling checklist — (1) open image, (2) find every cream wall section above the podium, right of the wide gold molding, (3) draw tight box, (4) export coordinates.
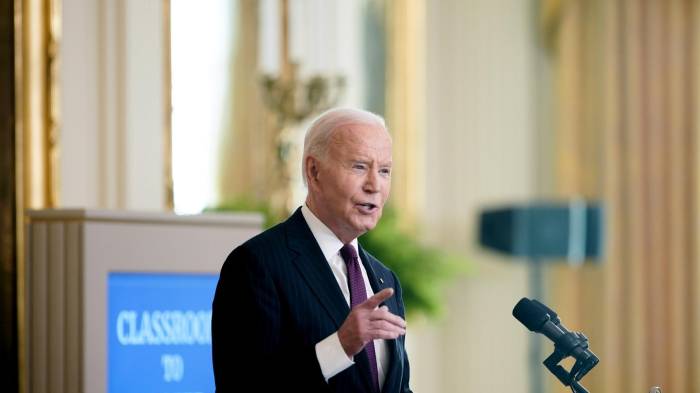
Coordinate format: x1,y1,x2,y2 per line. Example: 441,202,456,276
58,0,166,210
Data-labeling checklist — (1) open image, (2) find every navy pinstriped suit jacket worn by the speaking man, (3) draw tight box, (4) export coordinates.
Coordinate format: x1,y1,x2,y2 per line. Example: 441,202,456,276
212,209,411,393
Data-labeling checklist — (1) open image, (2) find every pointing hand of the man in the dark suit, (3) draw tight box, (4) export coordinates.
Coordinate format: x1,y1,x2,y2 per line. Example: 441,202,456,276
338,288,406,357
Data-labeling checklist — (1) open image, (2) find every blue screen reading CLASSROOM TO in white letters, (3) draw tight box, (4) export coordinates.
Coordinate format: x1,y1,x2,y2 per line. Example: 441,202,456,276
107,273,218,393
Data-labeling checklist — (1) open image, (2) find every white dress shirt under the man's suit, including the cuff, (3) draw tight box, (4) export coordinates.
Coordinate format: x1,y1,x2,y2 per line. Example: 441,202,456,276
301,204,389,388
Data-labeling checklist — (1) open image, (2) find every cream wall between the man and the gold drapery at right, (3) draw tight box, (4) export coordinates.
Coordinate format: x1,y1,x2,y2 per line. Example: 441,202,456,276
408,0,538,393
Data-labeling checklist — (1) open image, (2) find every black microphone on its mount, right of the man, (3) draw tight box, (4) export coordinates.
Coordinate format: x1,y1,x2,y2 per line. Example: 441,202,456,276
513,298,599,380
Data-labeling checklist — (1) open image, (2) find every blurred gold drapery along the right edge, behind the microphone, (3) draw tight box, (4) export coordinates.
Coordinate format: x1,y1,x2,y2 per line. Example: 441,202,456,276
550,0,700,392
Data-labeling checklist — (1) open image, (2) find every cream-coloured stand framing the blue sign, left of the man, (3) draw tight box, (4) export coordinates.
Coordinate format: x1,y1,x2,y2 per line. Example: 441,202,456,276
25,209,262,393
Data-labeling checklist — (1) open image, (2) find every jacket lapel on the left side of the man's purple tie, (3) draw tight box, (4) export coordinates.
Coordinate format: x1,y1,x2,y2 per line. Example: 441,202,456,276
285,209,350,329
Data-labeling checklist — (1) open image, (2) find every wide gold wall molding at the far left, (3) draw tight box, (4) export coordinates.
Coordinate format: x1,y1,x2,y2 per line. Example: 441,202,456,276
14,0,61,392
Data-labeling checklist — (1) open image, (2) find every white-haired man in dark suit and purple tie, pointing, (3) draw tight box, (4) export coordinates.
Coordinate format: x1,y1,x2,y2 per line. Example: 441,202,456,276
212,109,411,393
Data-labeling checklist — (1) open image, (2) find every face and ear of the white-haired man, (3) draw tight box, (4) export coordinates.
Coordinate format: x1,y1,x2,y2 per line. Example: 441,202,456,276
306,125,391,243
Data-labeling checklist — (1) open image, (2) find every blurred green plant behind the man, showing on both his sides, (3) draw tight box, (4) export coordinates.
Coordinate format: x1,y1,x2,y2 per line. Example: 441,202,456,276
205,198,470,317
